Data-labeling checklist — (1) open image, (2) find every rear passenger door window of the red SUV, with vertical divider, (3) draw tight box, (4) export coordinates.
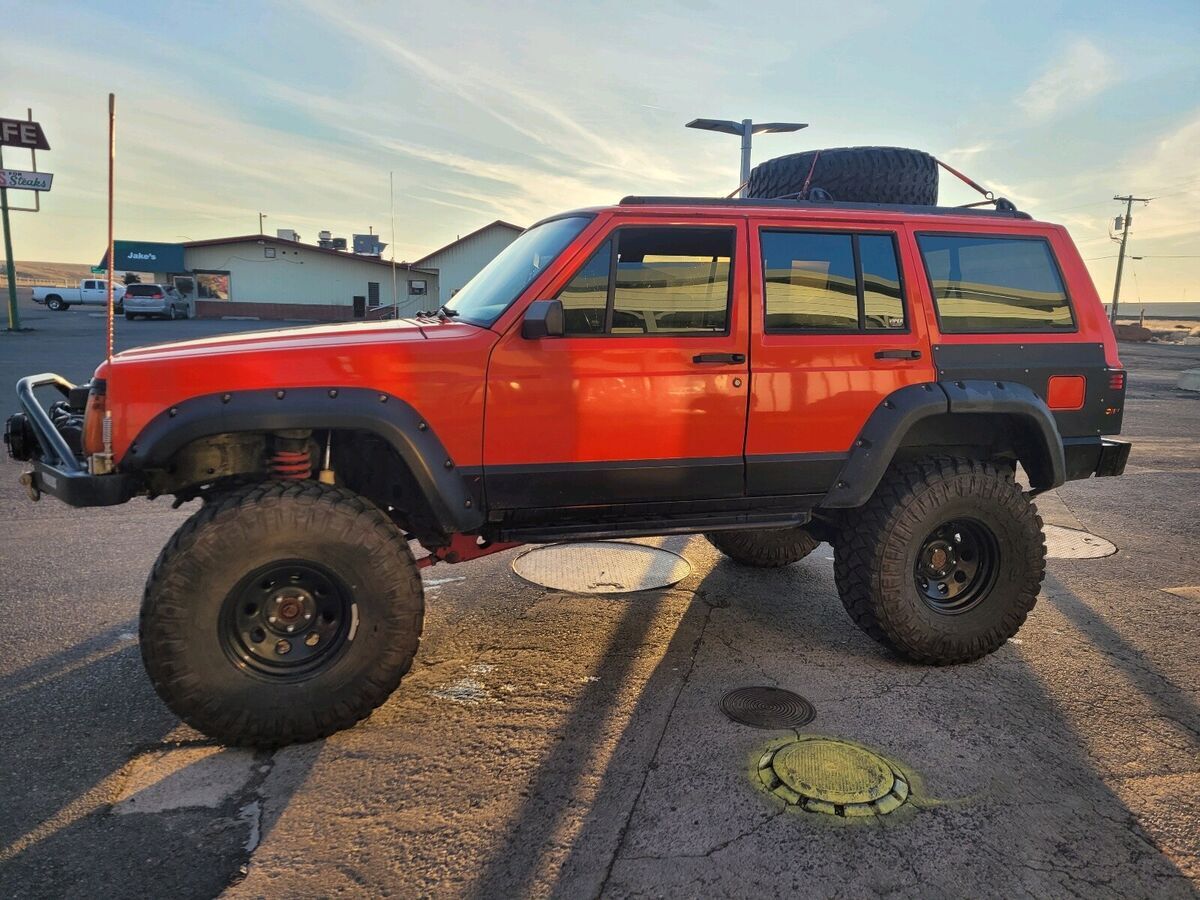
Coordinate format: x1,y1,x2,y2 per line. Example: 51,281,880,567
760,230,906,332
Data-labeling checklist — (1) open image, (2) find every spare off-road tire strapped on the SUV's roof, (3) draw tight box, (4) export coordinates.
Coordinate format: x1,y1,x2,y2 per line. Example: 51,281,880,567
746,146,937,206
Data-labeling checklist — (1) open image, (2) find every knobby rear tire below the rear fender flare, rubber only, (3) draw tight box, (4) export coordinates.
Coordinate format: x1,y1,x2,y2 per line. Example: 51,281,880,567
834,458,1045,665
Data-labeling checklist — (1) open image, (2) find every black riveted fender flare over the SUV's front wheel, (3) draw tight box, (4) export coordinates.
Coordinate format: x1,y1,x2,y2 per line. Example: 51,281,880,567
120,388,484,534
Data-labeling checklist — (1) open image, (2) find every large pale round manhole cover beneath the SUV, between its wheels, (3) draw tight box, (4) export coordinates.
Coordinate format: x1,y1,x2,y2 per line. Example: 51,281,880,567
512,541,691,594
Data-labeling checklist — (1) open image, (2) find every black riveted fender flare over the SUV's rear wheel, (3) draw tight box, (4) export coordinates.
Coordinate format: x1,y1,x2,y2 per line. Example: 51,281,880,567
820,380,1067,509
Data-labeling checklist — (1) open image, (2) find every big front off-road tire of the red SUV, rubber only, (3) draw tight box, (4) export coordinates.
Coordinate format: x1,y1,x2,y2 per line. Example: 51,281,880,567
139,481,425,748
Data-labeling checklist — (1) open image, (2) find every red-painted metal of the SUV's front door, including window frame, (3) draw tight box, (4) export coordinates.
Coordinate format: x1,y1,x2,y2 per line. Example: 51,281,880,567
484,215,750,466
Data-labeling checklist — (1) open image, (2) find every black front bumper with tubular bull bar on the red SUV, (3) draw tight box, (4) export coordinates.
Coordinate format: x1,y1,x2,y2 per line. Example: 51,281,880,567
10,372,138,506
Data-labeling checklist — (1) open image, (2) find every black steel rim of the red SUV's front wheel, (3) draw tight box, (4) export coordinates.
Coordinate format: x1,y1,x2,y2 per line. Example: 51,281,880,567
221,562,354,679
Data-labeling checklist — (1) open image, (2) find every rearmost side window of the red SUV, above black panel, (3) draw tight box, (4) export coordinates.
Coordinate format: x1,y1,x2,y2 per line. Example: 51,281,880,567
917,234,1075,334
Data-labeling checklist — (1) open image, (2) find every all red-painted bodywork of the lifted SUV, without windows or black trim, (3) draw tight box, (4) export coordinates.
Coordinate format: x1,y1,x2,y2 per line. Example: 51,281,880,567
97,200,1120,494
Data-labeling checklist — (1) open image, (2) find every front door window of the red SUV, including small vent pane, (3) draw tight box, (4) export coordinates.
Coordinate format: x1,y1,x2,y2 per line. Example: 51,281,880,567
558,227,736,335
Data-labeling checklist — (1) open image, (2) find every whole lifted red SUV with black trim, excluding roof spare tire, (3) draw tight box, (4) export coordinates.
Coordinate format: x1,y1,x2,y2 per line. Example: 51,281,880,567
6,198,1129,745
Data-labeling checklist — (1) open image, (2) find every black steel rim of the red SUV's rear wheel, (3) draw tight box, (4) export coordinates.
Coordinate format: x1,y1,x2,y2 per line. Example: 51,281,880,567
913,518,1000,614
